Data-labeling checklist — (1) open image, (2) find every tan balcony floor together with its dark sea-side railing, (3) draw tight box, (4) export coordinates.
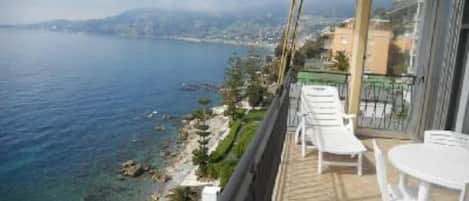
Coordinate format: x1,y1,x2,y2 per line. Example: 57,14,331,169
219,71,459,201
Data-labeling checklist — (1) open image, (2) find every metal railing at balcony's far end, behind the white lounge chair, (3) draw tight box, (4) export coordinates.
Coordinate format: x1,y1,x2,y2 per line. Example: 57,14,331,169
298,71,415,131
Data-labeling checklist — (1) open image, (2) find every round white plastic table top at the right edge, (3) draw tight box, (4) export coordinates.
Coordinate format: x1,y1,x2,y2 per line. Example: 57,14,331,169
388,144,469,190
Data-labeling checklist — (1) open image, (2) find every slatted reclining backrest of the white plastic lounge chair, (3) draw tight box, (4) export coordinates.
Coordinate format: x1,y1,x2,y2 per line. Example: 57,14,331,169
300,85,344,127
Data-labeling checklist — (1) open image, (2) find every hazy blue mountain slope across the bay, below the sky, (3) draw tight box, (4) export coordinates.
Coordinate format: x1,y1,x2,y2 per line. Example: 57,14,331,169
2,0,389,43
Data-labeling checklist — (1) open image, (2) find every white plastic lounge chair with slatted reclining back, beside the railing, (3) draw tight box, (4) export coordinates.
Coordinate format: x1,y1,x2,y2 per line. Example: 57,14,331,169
295,85,366,175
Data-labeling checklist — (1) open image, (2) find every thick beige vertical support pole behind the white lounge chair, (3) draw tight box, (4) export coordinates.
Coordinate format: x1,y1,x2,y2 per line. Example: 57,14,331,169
348,0,372,128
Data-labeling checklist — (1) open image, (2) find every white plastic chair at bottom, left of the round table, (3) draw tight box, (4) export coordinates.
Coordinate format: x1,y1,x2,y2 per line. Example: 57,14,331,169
373,139,418,201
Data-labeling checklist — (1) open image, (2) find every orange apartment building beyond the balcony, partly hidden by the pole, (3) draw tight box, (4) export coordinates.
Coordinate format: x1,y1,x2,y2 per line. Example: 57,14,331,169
322,18,393,75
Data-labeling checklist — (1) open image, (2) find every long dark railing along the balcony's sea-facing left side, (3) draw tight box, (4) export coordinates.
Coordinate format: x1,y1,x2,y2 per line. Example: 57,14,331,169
218,71,292,201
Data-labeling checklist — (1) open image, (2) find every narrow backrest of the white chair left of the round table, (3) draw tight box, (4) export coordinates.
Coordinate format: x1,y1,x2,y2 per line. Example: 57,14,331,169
373,139,390,201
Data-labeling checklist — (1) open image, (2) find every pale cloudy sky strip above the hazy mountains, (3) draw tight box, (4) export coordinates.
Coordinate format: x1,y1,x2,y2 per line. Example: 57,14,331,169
0,0,282,24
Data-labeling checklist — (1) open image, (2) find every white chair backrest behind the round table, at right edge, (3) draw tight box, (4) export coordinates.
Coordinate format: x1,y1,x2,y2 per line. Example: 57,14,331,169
424,130,469,149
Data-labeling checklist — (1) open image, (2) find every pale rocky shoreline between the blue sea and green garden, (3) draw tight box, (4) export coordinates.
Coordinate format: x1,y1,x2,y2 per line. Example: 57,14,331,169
117,106,229,201
